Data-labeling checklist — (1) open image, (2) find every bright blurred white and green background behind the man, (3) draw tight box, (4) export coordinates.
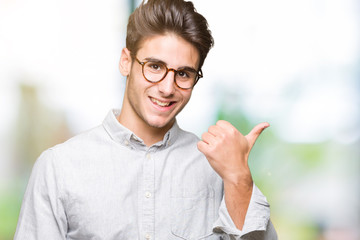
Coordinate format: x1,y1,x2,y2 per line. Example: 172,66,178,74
0,0,360,240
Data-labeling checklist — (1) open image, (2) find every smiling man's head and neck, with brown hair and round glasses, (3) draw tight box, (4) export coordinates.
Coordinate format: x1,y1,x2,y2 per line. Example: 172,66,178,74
118,0,213,145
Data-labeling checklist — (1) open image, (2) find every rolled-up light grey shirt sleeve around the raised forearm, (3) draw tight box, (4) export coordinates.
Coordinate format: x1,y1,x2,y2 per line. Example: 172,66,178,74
213,184,277,240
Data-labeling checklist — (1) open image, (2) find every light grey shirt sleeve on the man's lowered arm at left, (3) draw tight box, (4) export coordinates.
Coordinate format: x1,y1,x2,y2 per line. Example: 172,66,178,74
14,150,67,240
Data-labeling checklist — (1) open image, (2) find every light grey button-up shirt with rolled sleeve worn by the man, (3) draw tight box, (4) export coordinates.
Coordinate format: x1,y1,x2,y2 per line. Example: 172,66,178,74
15,110,277,240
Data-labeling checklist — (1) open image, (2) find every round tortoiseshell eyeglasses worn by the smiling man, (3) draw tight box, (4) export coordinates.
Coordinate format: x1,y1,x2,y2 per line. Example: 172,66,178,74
135,57,203,90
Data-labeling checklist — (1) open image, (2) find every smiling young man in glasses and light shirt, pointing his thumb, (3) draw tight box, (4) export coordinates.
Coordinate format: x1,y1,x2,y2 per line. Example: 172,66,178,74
15,0,277,240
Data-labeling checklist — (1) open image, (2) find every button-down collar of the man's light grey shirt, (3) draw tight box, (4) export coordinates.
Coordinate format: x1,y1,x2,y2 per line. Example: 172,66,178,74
103,109,180,149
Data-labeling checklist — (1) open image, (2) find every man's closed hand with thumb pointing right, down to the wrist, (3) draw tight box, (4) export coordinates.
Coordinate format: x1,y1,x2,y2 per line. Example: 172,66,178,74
198,120,270,187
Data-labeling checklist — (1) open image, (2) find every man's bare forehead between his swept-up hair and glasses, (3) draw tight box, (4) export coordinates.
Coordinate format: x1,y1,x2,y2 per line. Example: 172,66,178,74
137,33,200,69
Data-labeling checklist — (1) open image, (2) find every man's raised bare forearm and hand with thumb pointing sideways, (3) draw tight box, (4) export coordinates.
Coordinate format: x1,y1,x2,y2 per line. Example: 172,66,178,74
198,121,276,237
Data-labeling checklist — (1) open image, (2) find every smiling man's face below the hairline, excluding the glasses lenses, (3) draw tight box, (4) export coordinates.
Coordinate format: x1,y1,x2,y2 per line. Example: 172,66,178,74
120,34,199,130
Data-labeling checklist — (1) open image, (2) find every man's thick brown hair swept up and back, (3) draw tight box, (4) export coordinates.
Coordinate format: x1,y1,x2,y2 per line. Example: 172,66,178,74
126,0,214,69
